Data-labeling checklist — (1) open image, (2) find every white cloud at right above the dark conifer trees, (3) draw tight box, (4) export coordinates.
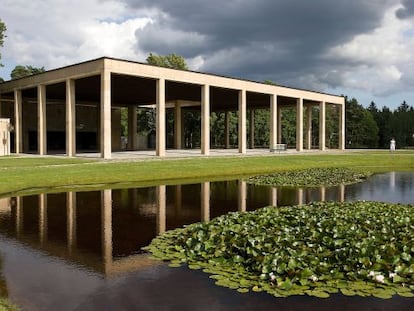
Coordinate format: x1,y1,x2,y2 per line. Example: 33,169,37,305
325,6,414,96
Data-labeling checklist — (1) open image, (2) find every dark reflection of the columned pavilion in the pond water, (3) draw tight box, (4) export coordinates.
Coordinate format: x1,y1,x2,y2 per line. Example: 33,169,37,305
0,181,345,276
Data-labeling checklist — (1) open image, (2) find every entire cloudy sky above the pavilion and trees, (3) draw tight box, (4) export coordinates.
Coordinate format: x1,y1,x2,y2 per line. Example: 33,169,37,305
0,0,414,108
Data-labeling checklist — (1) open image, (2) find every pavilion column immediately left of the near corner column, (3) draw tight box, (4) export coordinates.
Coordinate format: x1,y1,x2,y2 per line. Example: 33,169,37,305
66,79,76,157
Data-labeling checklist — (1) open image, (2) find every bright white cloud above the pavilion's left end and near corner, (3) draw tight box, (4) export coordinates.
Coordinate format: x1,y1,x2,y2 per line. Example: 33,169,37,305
1,0,150,69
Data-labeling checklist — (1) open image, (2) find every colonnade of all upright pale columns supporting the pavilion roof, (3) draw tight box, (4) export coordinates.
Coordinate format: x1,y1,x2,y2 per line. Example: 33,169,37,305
9,74,345,159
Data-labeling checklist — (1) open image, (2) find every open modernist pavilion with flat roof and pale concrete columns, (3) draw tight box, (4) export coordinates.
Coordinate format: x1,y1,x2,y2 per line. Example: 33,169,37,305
0,57,345,159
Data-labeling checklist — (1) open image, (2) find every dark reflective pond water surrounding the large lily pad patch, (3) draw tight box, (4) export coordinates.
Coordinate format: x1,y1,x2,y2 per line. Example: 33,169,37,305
0,172,414,310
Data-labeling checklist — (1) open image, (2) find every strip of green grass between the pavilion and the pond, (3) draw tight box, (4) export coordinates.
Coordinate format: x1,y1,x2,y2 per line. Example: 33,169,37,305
0,151,414,196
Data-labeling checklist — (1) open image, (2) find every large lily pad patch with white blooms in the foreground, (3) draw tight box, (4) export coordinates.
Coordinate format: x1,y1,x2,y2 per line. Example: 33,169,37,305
145,201,414,298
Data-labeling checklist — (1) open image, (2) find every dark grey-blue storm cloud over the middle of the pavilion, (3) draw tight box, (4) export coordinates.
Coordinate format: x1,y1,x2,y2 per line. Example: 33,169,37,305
125,0,392,87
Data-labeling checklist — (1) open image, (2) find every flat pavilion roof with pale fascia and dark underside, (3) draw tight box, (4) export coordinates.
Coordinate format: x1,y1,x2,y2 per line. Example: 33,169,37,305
0,57,345,106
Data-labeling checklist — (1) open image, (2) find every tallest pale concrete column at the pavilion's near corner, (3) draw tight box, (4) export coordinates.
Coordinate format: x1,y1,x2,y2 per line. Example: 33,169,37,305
100,70,112,159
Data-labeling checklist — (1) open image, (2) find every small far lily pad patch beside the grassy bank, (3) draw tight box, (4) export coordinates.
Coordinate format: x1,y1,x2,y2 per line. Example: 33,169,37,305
247,167,369,187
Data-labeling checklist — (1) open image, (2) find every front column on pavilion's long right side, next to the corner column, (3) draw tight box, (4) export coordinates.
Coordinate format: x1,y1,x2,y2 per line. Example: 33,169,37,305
156,78,166,157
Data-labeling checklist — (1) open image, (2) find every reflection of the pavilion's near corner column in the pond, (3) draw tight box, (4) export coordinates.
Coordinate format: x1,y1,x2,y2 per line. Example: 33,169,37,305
101,189,113,273
